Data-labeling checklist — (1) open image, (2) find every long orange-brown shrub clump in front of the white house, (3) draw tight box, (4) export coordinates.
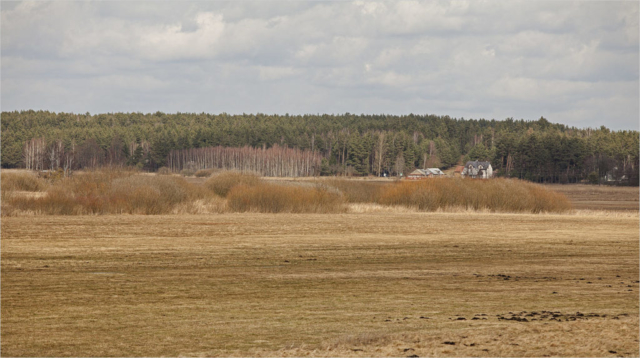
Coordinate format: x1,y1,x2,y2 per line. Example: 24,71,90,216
379,179,571,213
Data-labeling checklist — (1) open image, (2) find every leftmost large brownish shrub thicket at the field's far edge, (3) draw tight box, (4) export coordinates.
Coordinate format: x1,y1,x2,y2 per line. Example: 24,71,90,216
3,170,214,215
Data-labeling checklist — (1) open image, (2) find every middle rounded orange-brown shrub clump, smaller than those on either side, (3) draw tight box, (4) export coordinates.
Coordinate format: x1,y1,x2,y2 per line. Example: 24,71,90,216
227,184,345,213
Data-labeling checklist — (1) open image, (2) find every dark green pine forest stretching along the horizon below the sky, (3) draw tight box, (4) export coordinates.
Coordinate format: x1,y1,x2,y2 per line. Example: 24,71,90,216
1,110,639,185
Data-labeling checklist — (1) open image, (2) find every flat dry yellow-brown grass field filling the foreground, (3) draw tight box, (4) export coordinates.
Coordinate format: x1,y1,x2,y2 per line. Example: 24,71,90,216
1,212,640,357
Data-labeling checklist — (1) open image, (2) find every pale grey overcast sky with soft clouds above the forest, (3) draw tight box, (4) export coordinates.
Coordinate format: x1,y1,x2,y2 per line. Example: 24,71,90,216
0,1,639,130
